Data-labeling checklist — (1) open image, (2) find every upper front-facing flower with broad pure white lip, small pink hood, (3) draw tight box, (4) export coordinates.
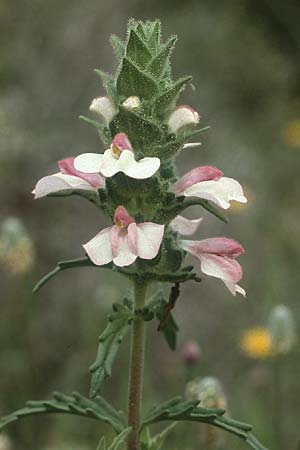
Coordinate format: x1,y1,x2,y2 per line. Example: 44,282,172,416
74,133,160,179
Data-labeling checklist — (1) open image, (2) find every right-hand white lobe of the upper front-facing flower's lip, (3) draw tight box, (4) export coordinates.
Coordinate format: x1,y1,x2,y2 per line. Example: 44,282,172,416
118,150,160,179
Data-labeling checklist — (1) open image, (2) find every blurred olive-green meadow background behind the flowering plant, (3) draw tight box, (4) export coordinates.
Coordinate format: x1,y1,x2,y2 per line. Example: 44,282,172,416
0,0,300,450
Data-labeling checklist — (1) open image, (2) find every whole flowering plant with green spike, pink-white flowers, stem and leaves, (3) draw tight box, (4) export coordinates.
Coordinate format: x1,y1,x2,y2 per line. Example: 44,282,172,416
0,20,263,450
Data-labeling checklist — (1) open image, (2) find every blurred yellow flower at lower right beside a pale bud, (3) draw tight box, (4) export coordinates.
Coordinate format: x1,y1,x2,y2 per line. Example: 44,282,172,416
240,327,274,359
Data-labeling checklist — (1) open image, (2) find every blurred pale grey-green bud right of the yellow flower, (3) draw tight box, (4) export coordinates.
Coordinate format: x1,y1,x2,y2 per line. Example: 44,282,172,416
268,305,296,354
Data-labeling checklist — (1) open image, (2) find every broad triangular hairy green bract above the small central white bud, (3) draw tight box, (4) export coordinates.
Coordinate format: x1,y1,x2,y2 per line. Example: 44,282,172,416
117,57,158,99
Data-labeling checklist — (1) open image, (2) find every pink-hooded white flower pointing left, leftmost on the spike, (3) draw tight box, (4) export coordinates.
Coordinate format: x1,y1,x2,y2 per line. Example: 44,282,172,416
32,157,105,198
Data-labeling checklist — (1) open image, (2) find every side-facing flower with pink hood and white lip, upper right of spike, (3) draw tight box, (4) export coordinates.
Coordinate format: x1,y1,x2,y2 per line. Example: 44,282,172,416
172,166,247,209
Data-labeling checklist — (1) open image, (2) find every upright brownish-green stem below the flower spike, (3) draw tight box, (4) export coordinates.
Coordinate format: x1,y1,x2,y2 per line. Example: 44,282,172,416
127,280,147,450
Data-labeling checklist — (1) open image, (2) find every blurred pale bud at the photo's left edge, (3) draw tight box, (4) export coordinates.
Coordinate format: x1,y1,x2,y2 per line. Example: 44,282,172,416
0,217,34,274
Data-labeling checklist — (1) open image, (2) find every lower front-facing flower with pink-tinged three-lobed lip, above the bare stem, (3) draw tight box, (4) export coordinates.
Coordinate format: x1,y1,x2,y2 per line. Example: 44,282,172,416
83,206,164,267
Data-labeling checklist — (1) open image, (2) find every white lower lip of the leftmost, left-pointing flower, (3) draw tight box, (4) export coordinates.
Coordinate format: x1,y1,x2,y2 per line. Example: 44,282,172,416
33,173,94,198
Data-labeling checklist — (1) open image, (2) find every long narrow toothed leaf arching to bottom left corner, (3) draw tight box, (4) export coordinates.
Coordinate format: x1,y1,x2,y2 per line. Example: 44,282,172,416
0,392,126,433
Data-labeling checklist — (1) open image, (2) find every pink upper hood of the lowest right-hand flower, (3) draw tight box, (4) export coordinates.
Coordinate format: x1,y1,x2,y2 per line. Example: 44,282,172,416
194,237,245,258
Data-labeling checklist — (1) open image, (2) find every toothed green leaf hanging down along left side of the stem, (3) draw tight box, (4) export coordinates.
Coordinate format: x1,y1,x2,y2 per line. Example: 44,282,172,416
90,305,133,398
